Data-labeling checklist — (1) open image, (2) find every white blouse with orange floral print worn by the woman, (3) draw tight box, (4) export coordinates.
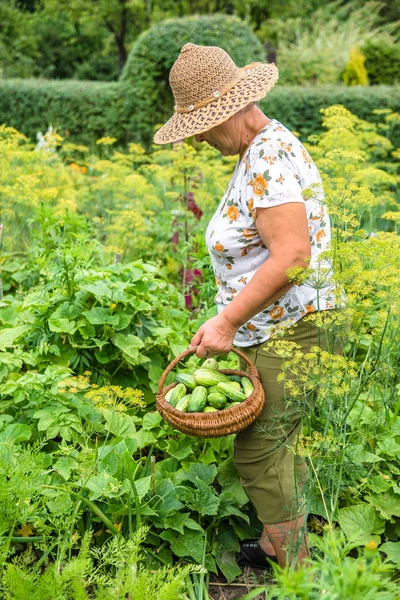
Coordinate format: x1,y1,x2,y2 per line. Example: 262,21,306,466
206,119,337,347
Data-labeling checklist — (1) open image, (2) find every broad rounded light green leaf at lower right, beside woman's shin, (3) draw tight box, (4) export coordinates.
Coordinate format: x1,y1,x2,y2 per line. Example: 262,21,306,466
338,504,385,544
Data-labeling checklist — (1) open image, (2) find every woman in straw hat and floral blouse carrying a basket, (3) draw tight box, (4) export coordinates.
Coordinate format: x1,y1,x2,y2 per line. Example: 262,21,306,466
154,44,335,566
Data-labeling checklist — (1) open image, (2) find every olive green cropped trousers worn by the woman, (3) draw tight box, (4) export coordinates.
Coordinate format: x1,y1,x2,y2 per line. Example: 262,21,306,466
234,319,332,525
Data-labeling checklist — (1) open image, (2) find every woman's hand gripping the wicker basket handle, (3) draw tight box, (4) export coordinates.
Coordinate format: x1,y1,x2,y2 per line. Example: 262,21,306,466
189,313,237,358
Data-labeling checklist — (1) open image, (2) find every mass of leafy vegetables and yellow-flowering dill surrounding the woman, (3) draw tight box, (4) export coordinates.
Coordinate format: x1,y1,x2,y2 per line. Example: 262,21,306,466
0,106,400,600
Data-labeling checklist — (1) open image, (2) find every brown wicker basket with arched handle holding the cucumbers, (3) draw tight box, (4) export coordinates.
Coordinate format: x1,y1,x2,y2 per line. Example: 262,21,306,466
157,348,264,438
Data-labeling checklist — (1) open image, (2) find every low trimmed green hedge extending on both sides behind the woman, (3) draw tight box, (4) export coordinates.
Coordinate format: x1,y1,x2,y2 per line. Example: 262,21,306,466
0,79,400,147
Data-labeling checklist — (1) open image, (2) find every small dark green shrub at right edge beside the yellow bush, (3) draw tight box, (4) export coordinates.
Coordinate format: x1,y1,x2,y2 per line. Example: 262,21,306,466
362,40,400,85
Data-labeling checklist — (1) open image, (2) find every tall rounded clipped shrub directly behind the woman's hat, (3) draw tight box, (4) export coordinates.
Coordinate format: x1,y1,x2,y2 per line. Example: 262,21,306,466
121,15,265,142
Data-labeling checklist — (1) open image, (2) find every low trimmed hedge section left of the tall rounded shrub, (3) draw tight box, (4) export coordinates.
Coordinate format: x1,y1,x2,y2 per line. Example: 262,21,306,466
0,79,128,145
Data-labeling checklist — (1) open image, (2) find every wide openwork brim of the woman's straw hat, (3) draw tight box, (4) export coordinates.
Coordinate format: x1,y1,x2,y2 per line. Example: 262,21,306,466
153,63,279,144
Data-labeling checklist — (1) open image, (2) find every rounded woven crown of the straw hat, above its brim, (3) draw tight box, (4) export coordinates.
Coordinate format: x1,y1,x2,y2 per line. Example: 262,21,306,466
169,44,245,113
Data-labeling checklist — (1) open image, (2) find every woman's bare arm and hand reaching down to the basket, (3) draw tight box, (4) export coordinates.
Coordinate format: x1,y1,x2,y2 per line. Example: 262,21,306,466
190,202,311,357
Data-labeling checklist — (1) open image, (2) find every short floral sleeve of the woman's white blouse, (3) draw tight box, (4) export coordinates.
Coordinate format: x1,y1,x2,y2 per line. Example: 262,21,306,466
246,143,304,216
